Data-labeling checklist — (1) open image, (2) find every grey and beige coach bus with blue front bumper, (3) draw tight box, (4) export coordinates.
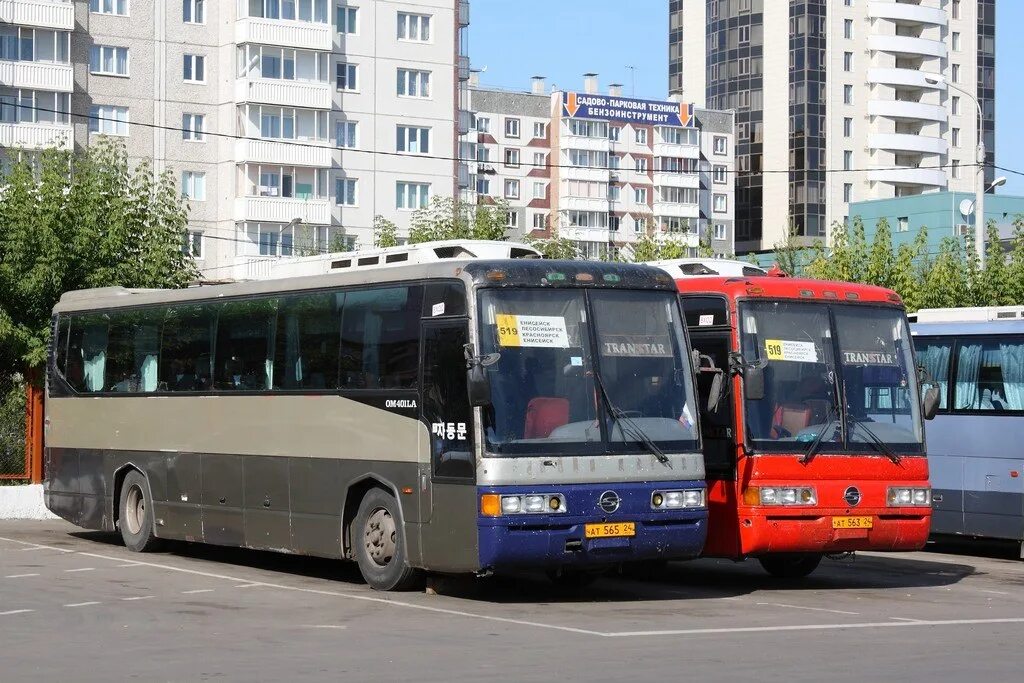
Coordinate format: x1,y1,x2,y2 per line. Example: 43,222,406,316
45,251,708,590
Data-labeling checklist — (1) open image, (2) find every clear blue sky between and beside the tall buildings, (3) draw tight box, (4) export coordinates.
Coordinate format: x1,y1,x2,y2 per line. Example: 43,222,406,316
469,0,1024,195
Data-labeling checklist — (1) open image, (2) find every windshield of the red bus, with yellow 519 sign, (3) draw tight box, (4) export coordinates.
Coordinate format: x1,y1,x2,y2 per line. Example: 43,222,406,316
740,301,924,455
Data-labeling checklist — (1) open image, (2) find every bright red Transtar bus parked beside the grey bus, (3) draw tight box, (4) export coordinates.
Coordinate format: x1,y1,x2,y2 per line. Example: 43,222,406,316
676,276,937,577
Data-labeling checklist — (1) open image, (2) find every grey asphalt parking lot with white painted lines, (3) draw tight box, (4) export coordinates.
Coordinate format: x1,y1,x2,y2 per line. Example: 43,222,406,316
0,521,1024,683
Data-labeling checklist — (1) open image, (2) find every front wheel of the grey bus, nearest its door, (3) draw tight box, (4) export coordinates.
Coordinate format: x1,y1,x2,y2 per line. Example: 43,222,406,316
351,488,423,591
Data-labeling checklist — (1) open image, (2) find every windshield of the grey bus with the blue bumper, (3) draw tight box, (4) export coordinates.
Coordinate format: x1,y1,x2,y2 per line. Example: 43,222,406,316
480,289,698,456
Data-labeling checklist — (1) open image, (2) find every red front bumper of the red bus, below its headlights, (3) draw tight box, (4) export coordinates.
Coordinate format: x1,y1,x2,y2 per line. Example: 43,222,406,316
739,508,932,555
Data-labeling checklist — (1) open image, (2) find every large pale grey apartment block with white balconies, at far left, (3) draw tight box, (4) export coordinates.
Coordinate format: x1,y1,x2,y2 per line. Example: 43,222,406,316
0,0,469,278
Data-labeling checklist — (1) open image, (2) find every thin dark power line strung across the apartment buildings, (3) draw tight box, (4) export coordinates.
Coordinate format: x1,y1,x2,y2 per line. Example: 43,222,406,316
6,104,1007,177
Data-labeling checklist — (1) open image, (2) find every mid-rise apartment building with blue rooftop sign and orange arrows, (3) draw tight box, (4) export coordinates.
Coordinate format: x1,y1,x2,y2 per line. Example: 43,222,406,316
471,74,735,258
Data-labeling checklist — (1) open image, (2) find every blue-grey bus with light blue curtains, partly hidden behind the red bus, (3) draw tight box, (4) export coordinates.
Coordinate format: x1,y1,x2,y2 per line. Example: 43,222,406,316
911,306,1024,558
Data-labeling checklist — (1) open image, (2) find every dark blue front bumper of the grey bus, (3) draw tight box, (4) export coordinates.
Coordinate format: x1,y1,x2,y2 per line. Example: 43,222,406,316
477,481,708,570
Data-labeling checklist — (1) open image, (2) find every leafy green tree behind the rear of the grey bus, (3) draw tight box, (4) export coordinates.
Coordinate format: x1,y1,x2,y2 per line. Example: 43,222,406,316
0,140,198,374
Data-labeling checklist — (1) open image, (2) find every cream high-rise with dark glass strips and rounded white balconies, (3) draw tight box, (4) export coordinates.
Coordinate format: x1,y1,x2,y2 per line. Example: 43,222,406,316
669,0,995,252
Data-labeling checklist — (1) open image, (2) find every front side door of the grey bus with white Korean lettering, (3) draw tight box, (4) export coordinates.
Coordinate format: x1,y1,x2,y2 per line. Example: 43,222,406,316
420,317,479,571
